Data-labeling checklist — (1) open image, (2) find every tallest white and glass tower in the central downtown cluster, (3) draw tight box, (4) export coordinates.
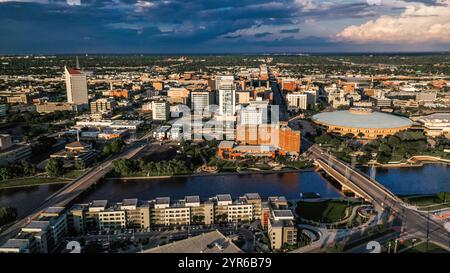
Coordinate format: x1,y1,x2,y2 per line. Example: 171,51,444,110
216,76,236,116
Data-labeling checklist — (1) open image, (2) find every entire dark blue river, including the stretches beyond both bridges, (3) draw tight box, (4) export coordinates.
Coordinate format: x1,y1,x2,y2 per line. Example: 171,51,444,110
0,164,450,216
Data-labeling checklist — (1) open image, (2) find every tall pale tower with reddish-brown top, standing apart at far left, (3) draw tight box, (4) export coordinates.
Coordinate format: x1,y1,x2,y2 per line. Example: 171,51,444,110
64,67,88,107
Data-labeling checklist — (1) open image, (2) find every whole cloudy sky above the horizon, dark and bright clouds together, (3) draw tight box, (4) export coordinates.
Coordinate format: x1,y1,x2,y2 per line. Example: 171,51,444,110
0,0,450,54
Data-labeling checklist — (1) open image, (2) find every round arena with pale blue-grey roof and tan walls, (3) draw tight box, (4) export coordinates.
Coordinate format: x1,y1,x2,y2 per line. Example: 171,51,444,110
312,108,412,139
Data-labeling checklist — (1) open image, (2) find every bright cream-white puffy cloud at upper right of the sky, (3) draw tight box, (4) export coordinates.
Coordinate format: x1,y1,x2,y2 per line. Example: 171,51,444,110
336,0,450,44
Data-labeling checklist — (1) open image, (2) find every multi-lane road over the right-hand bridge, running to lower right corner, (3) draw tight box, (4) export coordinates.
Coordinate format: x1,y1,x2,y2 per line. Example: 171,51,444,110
309,145,450,248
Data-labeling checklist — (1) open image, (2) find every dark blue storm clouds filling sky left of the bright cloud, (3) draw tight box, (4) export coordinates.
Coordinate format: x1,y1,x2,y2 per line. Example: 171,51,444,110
0,0,446,53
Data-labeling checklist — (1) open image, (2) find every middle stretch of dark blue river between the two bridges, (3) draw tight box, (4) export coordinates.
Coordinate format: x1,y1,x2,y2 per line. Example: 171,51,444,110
82,172,341,202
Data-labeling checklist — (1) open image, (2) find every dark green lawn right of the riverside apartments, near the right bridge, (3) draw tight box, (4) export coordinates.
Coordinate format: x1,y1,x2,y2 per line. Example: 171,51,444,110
296,200,352,223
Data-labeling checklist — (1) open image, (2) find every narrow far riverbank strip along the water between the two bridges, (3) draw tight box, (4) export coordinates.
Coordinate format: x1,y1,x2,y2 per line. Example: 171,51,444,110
105,168,314,181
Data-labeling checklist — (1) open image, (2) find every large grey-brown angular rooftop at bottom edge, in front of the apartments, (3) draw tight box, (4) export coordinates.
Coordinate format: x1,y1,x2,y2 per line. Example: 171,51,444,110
144,230,242,253
